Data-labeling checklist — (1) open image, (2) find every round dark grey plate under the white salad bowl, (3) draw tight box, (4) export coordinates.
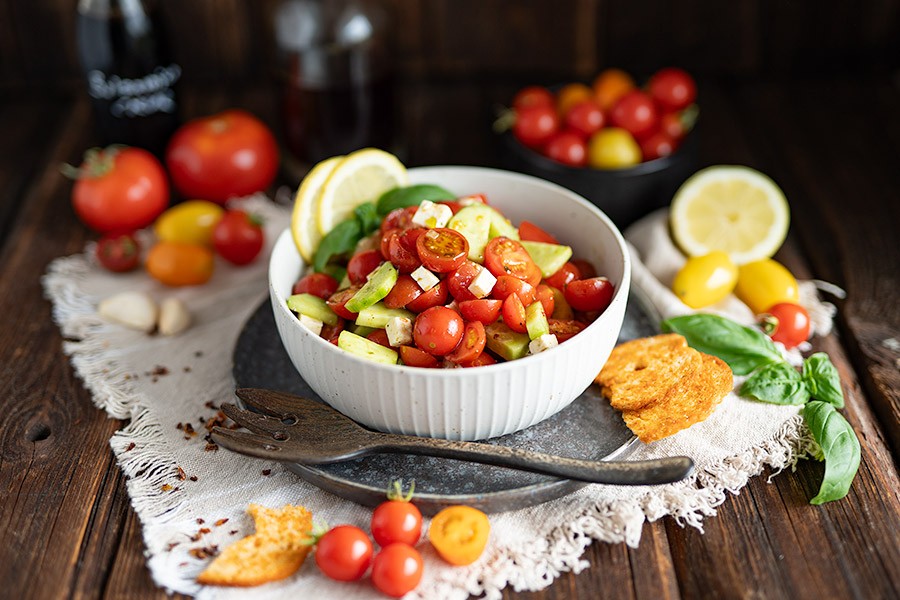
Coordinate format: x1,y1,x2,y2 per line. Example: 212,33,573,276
233,291,659,514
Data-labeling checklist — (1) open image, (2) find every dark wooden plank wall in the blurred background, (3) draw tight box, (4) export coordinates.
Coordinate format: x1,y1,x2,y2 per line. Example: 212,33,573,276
0,0,900,93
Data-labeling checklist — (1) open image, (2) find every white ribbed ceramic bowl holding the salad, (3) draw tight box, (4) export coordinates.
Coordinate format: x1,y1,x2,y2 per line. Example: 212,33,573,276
269,167,631,440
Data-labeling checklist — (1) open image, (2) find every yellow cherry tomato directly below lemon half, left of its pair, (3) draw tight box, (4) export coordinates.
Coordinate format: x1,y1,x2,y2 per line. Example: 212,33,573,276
672,250,738,308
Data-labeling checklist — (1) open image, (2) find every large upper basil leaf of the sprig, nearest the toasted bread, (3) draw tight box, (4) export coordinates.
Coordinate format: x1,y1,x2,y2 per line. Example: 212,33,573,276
661,314,784,375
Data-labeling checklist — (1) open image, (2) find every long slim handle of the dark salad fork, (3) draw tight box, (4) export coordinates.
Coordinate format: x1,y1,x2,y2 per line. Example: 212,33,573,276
377,434,694,485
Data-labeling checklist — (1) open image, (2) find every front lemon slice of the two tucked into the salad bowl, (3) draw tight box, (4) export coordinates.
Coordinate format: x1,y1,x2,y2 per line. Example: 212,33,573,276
318,148,409,235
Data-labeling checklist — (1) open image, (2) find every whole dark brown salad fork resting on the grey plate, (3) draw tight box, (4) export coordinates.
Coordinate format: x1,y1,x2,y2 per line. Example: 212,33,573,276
212,388,694,485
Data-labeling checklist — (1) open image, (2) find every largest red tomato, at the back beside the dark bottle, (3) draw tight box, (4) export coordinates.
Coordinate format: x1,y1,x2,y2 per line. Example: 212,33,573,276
166,110,278,204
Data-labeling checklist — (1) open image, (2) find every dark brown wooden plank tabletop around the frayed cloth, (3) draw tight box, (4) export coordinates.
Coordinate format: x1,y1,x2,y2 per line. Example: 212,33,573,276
0,79,900,599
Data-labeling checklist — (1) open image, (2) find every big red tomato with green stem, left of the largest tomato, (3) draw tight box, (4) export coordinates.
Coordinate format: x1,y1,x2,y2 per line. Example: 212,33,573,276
72,147,169,233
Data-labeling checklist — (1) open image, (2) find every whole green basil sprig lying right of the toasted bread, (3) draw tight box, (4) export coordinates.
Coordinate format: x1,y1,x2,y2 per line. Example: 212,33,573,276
661,314,860,504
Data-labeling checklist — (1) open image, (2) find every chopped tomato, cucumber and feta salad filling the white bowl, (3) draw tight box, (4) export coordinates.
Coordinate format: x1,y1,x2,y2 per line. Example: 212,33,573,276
288,186,614,368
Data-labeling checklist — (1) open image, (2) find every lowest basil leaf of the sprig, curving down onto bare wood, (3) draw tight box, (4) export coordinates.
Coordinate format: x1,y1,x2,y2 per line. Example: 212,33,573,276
803,400,860,504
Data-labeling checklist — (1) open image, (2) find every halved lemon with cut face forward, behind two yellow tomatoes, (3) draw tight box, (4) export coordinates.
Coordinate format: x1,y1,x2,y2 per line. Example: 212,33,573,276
669,166,790,265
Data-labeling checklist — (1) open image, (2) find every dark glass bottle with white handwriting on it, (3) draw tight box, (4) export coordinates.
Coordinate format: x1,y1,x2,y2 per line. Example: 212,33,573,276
76,0,181,155
